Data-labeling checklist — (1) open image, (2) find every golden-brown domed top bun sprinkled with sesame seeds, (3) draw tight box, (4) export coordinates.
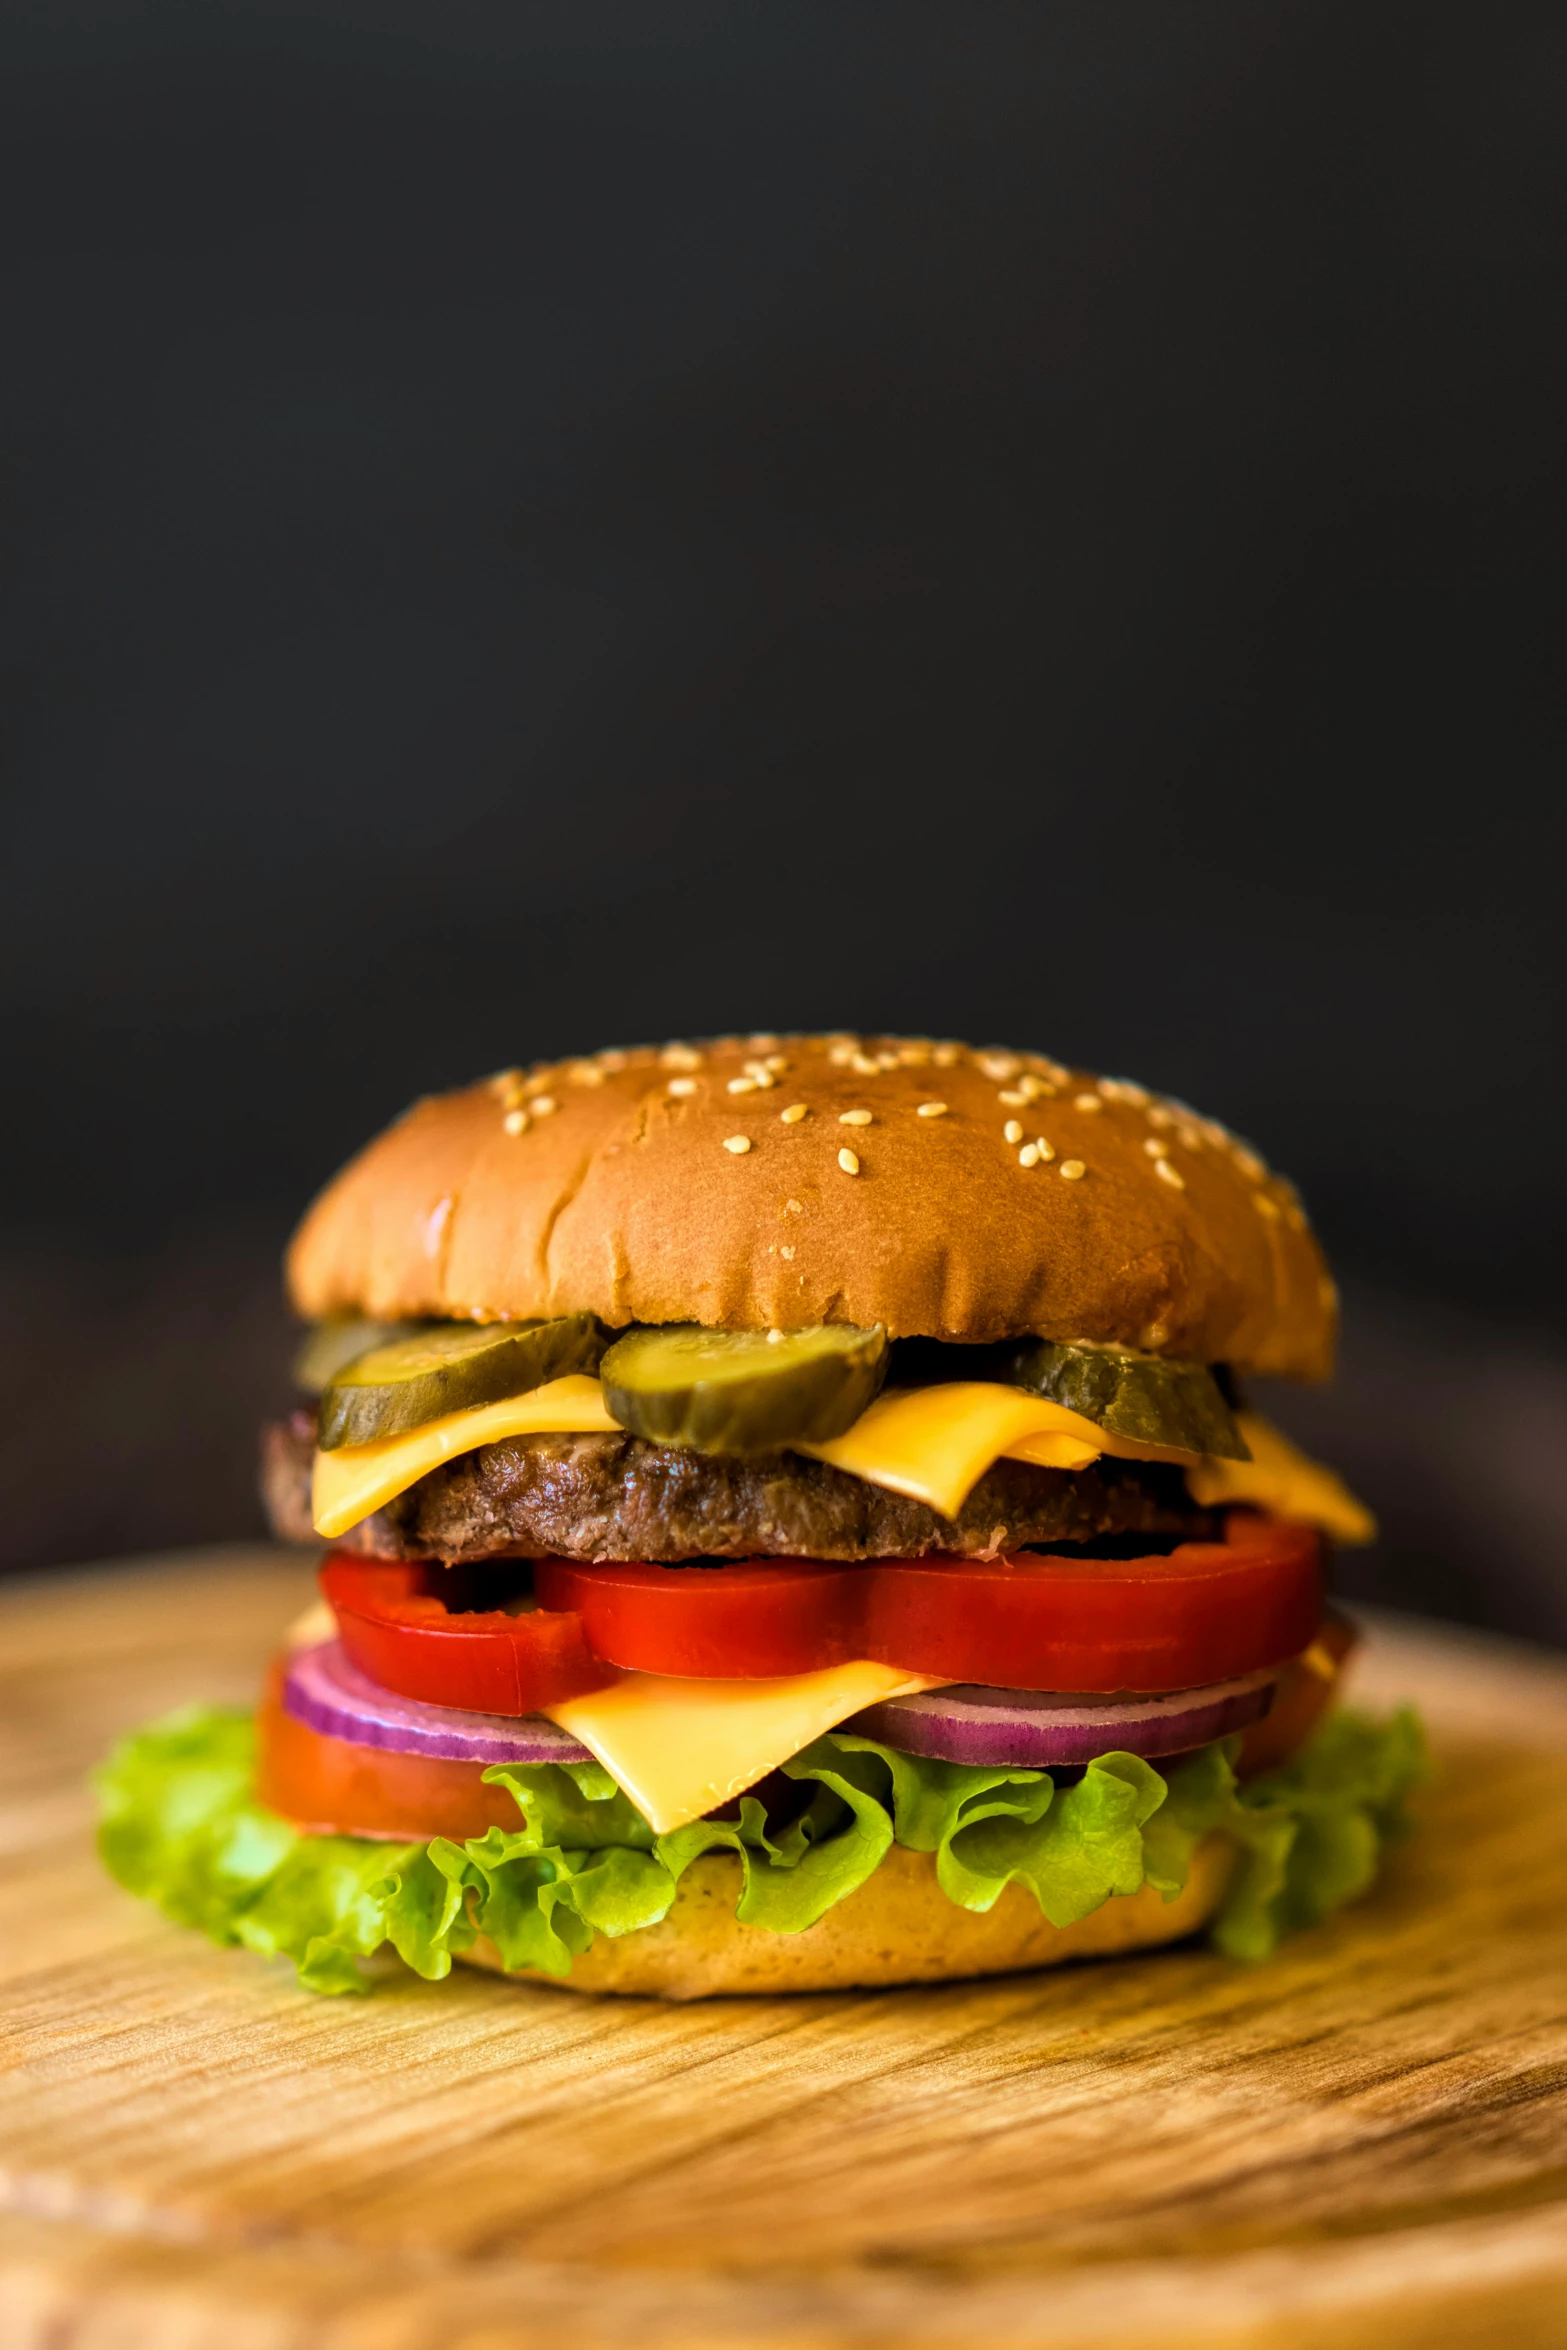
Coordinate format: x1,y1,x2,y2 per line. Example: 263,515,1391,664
289,1036,1334,1379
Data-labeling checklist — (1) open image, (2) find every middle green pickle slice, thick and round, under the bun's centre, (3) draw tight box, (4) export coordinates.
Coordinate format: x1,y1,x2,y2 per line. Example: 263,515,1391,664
601,1323,888,1452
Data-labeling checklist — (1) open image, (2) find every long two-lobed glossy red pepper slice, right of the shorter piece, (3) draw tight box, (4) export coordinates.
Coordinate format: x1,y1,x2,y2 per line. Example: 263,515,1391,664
535,1511,1323,1694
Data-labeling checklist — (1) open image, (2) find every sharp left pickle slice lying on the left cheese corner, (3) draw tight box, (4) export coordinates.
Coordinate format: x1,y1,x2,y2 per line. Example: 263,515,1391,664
317,1314,604,1452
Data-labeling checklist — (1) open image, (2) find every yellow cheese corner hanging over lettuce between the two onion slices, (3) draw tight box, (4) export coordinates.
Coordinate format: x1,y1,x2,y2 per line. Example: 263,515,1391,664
545,1664,947,1835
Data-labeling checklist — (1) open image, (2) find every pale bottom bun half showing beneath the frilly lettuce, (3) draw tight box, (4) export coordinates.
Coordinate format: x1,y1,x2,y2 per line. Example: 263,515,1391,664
463,1835,1236,2000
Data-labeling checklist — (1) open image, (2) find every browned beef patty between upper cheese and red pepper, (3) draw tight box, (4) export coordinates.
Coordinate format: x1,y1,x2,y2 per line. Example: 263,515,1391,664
261,1412,1215,1565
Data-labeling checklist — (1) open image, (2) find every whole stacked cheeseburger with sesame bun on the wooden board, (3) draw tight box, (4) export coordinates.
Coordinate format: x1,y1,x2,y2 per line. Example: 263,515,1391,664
101,1034,1419,1998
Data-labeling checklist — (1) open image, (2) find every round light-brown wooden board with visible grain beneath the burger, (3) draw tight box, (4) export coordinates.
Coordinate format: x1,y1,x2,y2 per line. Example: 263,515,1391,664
0,1549,1567,2350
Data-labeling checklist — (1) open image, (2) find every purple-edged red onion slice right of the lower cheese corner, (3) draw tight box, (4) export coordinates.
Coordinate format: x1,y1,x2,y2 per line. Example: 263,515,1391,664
839,1669,1278,1770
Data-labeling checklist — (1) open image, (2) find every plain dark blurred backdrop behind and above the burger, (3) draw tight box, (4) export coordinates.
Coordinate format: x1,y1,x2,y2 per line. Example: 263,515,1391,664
0,0,1567,1640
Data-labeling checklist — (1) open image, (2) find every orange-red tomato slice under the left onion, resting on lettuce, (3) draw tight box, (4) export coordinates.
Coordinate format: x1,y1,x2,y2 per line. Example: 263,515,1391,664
256,1664,522,1845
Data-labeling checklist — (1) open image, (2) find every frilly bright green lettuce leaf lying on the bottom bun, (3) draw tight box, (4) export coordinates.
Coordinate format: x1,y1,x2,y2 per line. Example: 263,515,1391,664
99,1708,1424,1990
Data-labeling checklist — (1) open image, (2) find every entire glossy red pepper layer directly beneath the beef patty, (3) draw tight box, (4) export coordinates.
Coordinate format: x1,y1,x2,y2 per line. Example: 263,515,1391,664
322,1511,1323,1716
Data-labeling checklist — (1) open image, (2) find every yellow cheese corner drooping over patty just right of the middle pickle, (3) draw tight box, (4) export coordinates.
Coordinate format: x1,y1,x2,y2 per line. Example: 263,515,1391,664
794,1379,1107,1518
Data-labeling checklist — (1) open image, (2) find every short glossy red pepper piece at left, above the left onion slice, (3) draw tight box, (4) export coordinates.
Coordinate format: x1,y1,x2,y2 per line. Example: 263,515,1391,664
320,1551,616,1713
